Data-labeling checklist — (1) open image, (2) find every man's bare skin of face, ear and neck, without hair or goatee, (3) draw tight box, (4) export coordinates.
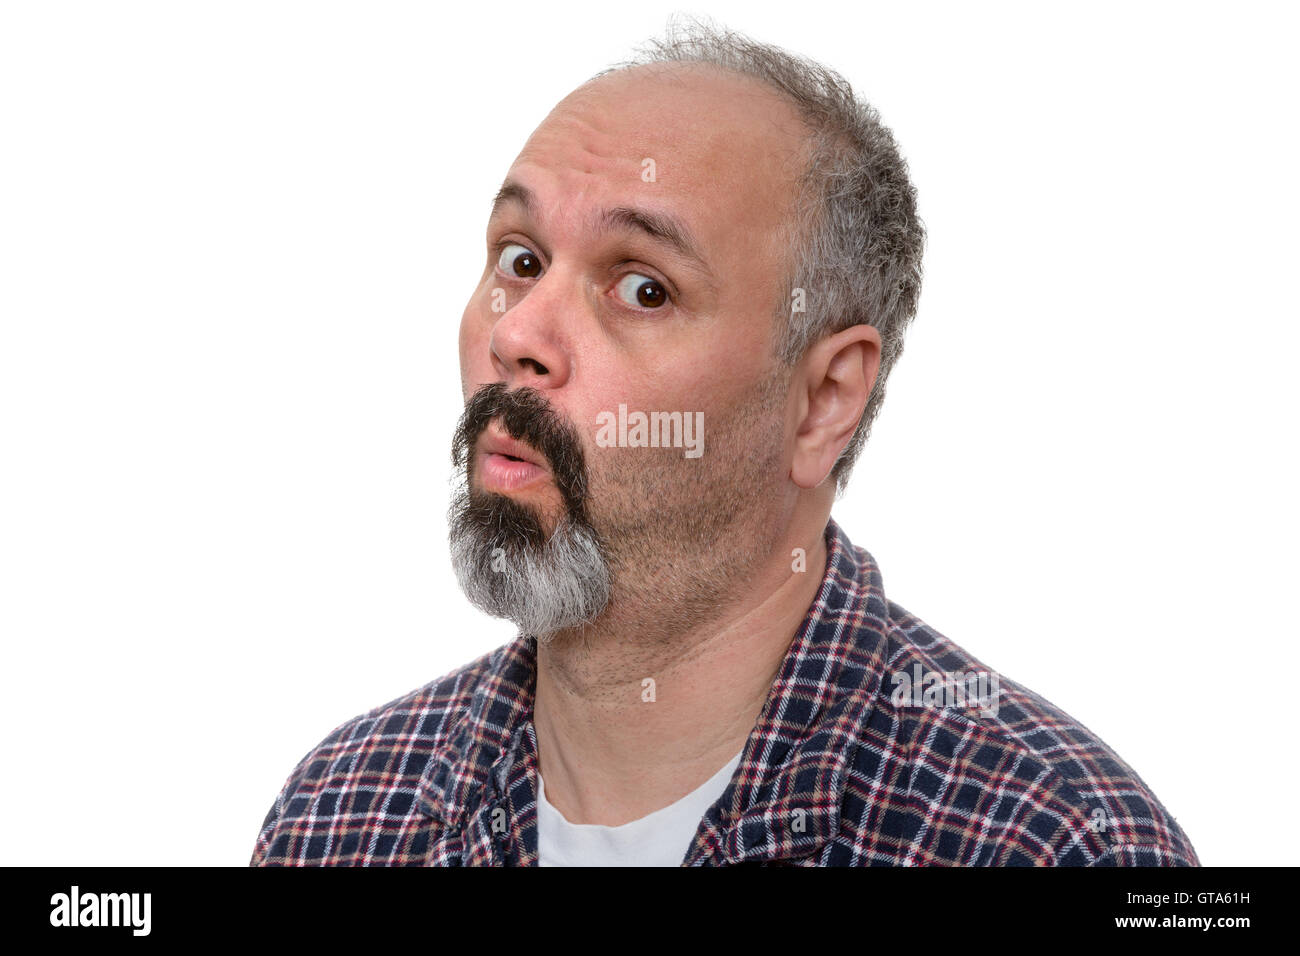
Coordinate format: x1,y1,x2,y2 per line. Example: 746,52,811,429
460,64,880,826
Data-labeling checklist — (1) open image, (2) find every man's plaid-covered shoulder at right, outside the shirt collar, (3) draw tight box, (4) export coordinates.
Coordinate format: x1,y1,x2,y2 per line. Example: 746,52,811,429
850,601,1200,866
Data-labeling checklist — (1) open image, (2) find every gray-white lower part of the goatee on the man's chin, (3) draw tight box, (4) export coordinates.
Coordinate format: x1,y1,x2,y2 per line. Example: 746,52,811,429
447,488,611,644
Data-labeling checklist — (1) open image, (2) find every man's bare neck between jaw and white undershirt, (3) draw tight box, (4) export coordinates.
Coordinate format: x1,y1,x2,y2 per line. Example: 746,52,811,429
533,501,829,826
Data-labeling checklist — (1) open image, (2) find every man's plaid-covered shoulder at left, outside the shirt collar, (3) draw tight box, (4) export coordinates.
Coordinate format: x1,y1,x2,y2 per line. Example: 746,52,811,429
251,646,506,866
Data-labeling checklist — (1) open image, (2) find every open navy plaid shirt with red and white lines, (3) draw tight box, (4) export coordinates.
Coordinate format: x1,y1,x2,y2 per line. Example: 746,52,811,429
251,520,1200,866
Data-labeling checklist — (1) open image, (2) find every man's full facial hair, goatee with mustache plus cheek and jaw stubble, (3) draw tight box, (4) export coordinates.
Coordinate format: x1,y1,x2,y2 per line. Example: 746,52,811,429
449,369,788,644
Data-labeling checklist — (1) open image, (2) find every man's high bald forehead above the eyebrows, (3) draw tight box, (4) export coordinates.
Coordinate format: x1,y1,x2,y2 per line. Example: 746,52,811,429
507,64,807,261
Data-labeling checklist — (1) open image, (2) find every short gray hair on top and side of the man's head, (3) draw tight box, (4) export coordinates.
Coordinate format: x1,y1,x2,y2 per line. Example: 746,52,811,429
593,17,926,493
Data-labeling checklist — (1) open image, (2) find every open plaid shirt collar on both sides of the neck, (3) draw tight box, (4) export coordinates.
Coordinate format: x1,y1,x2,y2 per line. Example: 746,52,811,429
420,519,889,862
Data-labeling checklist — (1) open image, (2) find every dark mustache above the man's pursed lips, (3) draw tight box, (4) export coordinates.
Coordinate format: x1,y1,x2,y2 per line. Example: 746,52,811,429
451,382,589,519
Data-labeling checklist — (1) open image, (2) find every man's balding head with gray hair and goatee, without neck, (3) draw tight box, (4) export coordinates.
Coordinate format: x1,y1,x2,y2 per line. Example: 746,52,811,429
451,16,923,639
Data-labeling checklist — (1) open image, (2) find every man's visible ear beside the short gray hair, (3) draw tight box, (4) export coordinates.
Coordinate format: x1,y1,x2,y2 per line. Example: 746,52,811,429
790,325,880,488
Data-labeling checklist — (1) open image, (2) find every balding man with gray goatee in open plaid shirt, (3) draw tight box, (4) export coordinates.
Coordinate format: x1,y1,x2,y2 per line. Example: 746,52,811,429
252,18,1199,866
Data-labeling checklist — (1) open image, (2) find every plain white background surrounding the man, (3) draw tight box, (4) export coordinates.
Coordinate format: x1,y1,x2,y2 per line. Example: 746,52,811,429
0,0,1300,865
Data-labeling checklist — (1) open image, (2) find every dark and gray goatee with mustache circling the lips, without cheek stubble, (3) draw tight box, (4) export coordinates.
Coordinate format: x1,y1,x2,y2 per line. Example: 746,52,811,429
447,382,611,644
